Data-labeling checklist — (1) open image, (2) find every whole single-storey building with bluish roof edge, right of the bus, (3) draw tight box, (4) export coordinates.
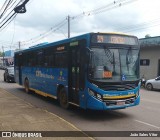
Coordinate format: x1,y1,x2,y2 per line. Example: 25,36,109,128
139,36,160,79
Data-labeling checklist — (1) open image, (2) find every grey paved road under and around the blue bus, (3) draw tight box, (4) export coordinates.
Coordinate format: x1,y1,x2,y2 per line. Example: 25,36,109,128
0,70,160,140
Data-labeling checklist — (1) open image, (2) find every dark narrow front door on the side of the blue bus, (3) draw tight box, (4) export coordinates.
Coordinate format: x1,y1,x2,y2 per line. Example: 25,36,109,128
68,46,80,105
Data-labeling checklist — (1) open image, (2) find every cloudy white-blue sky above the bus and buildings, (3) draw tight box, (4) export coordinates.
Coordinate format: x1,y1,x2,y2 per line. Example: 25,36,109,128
0,0,160,51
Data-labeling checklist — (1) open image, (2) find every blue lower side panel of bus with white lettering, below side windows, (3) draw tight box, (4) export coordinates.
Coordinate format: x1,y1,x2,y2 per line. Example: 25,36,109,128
22,67,68,96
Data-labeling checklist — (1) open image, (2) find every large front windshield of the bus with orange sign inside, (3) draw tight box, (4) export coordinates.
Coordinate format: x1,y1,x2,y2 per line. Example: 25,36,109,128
89,45,139,82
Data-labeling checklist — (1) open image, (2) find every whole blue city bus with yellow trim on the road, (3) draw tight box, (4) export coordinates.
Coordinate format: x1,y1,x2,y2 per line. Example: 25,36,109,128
14,33,140,110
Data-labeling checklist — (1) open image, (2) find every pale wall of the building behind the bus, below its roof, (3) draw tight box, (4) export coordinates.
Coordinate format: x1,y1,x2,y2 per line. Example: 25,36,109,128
140,46,160,79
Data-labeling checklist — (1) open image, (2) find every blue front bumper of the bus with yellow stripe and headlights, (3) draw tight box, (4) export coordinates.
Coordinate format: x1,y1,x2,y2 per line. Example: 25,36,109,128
87,82,140,110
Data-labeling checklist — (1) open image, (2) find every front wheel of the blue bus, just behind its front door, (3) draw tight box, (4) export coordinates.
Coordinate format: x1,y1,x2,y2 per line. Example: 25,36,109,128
58,88,69,109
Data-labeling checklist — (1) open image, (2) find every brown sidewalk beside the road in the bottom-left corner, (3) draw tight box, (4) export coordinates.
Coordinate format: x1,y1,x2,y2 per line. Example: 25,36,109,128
0,70,93,140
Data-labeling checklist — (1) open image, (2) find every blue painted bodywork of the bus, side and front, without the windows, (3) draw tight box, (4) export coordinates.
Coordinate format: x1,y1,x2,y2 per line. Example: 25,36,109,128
15,33,140,110
